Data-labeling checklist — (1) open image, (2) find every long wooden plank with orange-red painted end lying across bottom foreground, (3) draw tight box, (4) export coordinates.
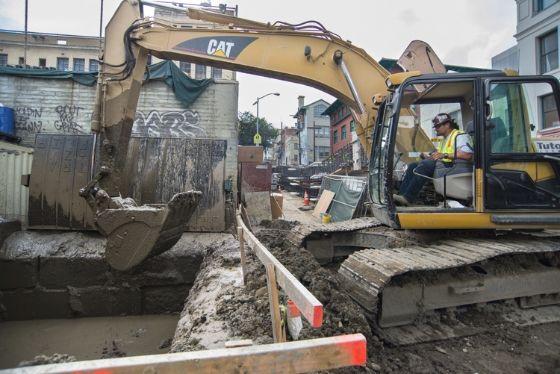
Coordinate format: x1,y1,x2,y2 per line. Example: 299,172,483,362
11,334,367,374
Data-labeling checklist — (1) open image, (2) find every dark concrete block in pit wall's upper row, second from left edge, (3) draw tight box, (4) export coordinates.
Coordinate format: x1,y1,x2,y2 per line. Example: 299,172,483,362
39,257,110,288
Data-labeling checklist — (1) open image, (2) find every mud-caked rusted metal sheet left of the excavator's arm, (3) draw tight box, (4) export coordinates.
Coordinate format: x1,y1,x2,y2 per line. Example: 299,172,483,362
29,134,95,230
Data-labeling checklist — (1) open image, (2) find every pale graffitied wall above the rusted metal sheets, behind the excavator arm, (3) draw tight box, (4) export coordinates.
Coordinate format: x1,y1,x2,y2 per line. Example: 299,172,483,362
0,75,238,190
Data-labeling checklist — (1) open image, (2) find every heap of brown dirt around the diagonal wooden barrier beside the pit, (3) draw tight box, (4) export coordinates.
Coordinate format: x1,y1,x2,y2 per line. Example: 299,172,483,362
212,220,383,371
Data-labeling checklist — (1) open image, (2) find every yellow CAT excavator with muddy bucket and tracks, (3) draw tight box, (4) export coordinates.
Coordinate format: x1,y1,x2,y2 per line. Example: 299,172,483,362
81,0,560,338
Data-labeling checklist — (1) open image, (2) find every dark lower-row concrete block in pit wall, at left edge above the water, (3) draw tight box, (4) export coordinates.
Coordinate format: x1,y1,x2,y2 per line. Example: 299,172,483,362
0,288,71,320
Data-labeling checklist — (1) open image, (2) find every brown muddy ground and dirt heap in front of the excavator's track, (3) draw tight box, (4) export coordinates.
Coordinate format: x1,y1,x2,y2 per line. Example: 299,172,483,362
194,221,560,373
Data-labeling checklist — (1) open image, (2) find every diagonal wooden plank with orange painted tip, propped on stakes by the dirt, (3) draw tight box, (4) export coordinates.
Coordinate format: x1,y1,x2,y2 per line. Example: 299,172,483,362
237,215,323,327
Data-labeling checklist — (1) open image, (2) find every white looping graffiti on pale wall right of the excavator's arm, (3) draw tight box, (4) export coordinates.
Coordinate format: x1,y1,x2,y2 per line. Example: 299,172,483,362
132,109,207,138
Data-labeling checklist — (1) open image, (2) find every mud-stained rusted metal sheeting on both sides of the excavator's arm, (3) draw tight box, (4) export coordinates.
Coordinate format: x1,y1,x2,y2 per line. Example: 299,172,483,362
29,134,227,232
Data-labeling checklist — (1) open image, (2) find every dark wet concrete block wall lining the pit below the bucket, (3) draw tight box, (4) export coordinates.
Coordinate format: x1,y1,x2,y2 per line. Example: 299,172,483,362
0,231,205,321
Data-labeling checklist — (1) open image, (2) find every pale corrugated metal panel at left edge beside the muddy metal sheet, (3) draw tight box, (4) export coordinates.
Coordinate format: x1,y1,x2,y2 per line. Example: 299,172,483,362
0,142,33,225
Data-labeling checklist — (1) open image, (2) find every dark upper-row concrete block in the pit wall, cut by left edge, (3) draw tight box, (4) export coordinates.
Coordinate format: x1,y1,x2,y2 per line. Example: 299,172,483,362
0,258,37,290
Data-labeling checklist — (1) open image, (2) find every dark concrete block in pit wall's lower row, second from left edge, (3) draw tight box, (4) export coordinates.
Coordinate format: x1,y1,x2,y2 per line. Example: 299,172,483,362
69,286,142,317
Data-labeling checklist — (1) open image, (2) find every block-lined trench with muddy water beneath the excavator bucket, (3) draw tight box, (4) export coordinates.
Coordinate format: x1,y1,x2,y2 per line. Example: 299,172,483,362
0,231,224,369
